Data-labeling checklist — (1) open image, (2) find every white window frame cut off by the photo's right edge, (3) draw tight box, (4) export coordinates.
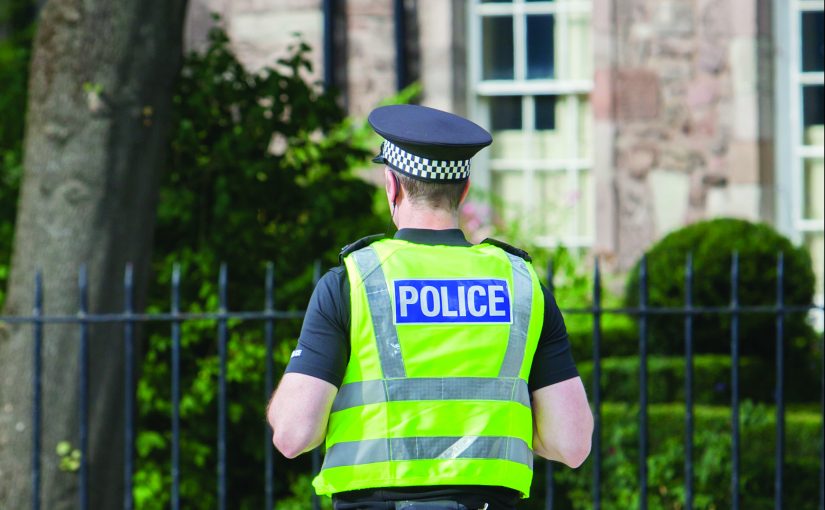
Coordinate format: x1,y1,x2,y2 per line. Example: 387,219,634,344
773,0,825,304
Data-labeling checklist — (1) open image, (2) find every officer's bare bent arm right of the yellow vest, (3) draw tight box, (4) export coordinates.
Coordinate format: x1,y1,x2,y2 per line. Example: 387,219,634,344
533,377,593,468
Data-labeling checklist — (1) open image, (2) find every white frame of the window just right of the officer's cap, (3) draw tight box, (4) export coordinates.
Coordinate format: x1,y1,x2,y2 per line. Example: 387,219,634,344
467,0,595,248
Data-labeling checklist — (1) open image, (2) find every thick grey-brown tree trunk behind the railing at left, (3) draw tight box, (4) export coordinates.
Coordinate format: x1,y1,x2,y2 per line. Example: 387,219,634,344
0,0,186,510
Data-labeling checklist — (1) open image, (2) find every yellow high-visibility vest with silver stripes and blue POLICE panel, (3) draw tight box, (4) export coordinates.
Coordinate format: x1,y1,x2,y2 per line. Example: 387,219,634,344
313,239,544,497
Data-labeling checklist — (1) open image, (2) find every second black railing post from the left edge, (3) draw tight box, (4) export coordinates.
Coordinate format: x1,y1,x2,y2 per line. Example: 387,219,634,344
77,264,89,510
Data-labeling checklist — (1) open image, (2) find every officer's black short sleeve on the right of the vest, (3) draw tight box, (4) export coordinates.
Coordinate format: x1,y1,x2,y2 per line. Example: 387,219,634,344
528,285,579,392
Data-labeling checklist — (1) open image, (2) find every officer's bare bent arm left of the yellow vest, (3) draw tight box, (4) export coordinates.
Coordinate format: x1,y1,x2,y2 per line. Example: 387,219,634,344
266,372,338,459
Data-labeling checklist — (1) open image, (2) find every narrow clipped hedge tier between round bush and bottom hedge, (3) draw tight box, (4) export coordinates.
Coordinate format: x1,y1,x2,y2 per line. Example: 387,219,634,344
577,354,775,405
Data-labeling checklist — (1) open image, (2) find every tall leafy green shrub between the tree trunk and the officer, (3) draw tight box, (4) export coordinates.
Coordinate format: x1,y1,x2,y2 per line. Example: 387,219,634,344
135,30,386,510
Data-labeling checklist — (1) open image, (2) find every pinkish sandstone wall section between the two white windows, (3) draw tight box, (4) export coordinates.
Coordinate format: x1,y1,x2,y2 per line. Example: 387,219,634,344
593,0,773,268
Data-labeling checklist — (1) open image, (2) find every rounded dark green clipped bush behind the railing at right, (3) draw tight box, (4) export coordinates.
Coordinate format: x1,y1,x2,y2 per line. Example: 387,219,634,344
625,219,816,362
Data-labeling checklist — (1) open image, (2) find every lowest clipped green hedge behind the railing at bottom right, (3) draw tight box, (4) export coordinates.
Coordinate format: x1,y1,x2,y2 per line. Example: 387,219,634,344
544,402,822,510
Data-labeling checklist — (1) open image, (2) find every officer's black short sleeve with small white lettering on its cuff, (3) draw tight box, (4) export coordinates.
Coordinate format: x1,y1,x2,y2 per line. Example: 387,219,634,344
286,267,350,388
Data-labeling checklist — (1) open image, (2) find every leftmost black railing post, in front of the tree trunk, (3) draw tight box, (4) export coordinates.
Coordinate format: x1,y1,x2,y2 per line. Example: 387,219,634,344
32,270,43,510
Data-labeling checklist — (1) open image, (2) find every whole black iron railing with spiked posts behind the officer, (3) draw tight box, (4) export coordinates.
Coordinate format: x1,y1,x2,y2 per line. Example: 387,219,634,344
0,253,825,510
